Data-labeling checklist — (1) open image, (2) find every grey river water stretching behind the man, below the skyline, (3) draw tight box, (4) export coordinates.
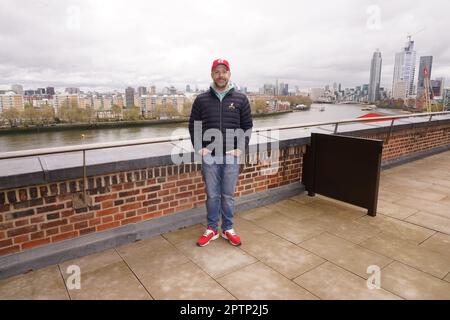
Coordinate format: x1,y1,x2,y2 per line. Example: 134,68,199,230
0,104,400,152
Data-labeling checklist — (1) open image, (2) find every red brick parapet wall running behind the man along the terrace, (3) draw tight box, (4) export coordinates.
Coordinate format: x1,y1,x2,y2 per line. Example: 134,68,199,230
0,124,450,256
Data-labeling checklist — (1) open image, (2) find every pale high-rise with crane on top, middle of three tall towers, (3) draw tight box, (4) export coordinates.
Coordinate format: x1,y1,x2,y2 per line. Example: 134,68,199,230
392,36,416,99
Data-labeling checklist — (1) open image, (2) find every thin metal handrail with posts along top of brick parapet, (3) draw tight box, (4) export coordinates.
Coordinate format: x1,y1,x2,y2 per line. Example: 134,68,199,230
0,111,450,208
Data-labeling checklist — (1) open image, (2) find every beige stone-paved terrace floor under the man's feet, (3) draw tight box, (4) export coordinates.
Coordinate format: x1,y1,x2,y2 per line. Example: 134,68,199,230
0,152,450,299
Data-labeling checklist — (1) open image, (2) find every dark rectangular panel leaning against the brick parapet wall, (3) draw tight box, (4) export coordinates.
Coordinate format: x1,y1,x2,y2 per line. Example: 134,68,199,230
302,133,383,216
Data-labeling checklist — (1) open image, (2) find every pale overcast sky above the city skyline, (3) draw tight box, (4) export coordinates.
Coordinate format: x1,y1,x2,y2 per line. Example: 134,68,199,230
0,0,450,91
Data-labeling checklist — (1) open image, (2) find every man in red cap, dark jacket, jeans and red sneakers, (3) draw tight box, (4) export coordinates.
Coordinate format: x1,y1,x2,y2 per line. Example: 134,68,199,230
189,59,253,247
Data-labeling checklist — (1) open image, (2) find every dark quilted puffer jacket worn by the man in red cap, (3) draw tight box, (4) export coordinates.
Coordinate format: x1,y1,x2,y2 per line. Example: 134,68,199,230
189,88,253,155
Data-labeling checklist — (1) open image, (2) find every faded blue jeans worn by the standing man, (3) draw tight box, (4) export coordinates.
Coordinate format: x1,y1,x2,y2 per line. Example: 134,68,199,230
202,154,239,230
